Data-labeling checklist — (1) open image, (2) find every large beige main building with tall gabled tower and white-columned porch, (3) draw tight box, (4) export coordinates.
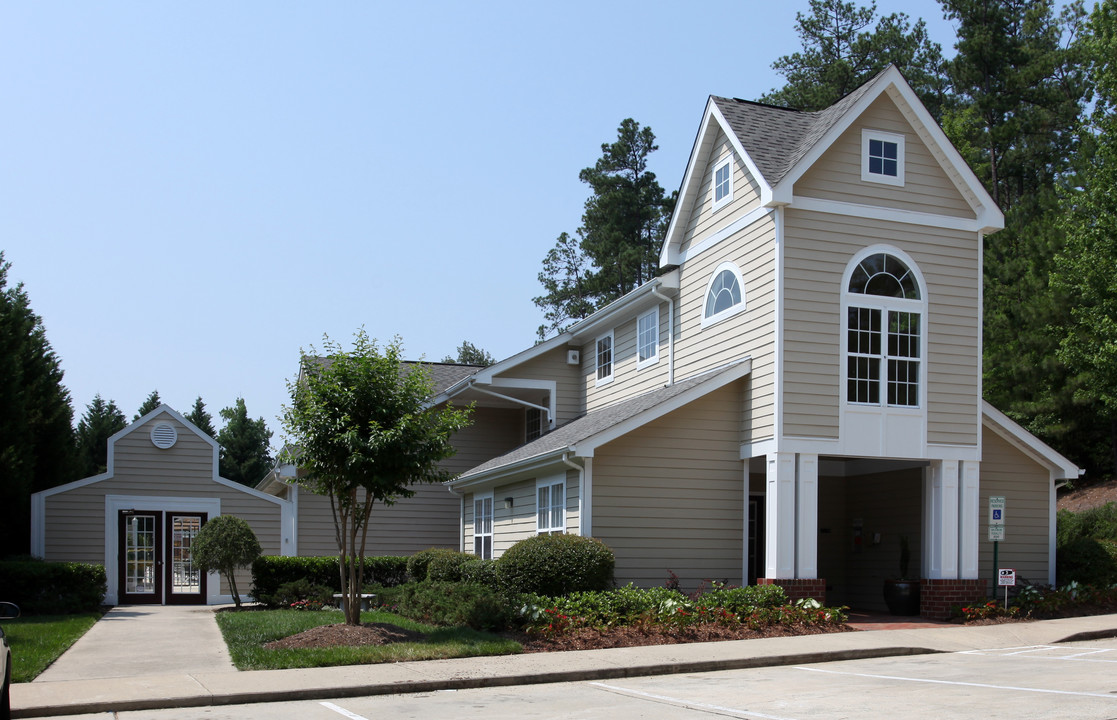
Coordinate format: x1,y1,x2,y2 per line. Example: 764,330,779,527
440,68,1079,616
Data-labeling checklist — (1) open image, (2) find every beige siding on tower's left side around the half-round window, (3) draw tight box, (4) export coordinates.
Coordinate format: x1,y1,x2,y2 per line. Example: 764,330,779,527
675,215,775,442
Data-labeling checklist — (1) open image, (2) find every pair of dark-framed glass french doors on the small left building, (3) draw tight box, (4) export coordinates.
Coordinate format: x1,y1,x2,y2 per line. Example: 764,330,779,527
117,510,206,605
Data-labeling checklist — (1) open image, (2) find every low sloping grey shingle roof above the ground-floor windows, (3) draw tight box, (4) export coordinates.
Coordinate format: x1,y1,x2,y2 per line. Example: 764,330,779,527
458,363,739,480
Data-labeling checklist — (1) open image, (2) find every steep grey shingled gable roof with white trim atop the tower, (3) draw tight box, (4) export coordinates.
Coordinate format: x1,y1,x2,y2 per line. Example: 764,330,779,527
659,65,1004,267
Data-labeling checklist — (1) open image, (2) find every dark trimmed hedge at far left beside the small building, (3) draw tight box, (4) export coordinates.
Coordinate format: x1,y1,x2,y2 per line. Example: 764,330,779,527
0,560,107,615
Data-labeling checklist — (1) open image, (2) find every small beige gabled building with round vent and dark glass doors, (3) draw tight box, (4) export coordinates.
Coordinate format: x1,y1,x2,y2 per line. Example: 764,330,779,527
31,405,295,605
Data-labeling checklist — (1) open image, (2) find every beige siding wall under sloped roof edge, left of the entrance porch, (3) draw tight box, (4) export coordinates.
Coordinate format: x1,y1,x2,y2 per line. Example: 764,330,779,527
593,382,744,589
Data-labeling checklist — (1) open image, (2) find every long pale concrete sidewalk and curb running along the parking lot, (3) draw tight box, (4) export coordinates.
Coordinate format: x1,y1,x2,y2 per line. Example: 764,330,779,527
11,608,1117,718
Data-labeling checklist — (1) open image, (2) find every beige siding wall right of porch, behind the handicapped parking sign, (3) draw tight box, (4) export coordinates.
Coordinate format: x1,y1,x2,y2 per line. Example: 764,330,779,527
977,429,1051,586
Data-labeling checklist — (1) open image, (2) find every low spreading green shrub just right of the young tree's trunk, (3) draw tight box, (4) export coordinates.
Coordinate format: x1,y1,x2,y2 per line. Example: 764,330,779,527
393,580,510,630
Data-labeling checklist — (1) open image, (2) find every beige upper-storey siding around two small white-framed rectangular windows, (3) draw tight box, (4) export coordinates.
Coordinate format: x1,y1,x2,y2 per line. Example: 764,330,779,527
582,303,668,411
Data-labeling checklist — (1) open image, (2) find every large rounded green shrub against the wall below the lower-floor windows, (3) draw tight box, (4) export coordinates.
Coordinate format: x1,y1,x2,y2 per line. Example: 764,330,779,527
496,535,615,595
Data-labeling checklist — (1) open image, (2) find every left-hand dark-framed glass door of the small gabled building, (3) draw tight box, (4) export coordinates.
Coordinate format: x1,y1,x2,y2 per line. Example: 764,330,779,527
117,510,163,605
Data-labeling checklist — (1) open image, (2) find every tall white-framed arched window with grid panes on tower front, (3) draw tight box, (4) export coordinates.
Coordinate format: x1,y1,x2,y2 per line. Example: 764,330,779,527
846,252,923,407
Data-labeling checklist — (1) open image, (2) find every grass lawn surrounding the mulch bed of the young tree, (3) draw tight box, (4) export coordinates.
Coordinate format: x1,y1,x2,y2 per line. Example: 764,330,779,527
217,609,522,670
